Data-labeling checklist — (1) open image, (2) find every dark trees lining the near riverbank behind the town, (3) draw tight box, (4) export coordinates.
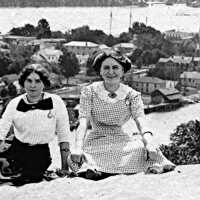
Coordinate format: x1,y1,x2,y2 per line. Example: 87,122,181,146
9,19,199,80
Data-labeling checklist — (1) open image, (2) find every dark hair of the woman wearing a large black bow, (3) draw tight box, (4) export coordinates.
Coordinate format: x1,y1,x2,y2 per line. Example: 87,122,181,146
19,63,51,87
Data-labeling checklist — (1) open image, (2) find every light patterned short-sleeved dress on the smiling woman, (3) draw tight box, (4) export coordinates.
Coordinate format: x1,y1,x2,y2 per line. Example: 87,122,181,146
79,82,173,173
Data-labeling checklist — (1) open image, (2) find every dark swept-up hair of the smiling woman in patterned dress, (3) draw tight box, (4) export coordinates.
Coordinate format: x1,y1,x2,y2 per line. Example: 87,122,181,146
92,50,131,74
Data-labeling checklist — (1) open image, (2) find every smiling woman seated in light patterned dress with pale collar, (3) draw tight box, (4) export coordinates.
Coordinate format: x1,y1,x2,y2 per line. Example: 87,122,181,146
73,51,175,179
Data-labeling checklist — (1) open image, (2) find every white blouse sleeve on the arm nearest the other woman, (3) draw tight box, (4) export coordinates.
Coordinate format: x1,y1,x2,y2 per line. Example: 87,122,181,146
54,97,70,143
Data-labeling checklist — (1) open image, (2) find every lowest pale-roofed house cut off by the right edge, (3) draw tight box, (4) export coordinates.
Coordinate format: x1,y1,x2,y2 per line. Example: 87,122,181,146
179,71,200,89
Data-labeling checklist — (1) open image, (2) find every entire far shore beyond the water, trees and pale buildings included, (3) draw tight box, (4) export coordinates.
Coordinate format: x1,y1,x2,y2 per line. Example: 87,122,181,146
0,0,200,7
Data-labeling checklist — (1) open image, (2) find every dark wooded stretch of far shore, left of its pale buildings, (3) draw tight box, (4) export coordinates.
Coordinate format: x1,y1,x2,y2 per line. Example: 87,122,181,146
0,0,138,7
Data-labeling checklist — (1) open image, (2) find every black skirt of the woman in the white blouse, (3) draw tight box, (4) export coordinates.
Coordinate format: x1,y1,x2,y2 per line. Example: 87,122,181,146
0,138,51,179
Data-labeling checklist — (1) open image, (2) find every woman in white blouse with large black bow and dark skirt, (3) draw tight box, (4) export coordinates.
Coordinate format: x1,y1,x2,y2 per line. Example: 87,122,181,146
0,64,70,183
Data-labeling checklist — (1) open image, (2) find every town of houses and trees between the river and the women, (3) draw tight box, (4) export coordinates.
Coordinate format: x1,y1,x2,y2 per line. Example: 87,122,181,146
0,19,200,126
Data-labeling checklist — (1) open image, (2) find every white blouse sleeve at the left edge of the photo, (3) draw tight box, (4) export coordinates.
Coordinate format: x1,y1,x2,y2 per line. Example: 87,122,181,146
0,101,16,140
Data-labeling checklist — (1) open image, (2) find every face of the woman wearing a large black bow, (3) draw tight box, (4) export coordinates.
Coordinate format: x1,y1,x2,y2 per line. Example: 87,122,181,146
24,72,44,98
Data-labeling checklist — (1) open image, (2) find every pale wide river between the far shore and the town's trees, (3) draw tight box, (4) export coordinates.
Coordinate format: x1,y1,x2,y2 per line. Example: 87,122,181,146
0,4,200,35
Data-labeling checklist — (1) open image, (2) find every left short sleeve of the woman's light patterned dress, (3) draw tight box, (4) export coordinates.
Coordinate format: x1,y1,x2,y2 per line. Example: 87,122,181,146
79,86,92,119
